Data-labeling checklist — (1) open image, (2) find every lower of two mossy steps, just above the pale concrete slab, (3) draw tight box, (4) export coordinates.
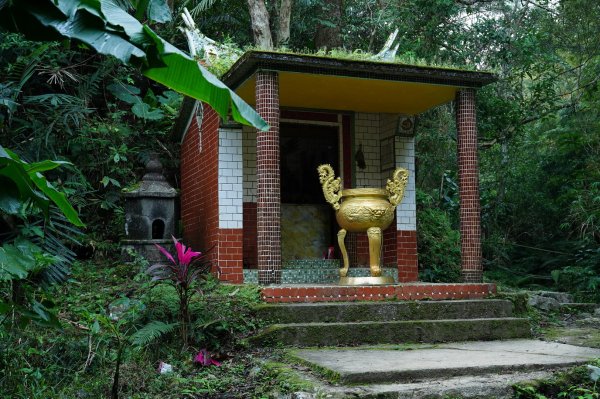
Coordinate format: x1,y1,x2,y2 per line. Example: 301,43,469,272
249,317,531,347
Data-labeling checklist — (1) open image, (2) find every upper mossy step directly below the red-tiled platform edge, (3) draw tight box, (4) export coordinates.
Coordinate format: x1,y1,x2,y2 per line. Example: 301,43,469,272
256,299,513,324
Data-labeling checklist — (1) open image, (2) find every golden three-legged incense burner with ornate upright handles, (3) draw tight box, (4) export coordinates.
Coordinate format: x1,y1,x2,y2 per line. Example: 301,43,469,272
317,165,408,285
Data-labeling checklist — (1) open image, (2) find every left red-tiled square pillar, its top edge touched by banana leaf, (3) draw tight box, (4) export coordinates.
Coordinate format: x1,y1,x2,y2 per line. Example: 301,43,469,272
256,71,281,284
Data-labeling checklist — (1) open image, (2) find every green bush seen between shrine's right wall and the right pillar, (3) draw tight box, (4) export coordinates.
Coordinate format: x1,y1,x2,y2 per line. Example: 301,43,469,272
417,191,461,283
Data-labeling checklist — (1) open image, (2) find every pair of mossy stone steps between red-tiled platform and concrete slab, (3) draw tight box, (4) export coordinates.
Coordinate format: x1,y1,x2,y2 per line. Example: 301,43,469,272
249,300,531,347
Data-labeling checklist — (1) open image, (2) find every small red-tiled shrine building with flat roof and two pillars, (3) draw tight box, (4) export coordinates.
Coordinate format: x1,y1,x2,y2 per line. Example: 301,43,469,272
173,51,495,299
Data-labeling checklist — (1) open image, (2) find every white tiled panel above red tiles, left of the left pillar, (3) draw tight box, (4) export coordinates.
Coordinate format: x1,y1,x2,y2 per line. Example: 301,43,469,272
219,128,243,229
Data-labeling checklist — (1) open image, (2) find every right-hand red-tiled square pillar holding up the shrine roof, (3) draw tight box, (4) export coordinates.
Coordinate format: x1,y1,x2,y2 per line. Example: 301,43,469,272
456,89,483,283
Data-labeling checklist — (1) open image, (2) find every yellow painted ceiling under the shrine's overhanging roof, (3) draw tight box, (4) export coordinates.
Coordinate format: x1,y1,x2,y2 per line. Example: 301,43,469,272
236,72,458,115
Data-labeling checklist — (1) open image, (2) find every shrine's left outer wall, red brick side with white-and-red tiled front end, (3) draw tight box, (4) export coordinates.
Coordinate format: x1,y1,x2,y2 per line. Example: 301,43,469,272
181,104,243,283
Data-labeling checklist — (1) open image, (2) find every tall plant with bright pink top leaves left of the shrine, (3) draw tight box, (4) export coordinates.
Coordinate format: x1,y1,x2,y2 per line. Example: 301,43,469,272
147,237,210,346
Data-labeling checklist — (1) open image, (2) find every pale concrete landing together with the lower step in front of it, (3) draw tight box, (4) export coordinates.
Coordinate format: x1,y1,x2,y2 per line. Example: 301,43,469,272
291,340,600,398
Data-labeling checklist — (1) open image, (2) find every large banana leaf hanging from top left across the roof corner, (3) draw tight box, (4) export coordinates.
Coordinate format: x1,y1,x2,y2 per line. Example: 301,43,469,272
0,0,267,129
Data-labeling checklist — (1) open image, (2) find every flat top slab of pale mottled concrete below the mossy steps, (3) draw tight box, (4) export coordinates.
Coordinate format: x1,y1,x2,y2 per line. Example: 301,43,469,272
295,340,600,383
